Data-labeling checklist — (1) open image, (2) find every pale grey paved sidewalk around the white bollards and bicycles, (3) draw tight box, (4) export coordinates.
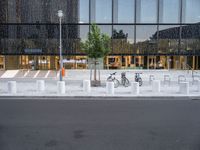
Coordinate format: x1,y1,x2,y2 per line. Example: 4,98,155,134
0,70,200,97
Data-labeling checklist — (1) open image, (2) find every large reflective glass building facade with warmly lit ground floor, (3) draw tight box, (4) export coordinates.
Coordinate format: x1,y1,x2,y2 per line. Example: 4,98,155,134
0,0,200,69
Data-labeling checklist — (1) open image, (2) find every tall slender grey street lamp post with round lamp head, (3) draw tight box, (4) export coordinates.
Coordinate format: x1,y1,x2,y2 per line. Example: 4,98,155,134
58,10,63,81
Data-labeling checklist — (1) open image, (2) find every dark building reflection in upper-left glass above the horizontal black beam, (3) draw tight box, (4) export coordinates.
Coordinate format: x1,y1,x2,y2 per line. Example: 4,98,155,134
5,0,79,23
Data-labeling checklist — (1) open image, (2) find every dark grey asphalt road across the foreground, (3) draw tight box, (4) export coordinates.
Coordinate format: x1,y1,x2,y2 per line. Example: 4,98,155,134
0,98,200,150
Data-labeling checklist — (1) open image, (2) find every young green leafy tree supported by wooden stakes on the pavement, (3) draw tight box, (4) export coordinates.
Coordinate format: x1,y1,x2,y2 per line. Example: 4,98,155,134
82,24,111,86
